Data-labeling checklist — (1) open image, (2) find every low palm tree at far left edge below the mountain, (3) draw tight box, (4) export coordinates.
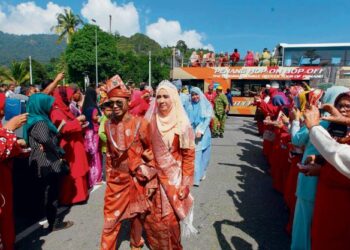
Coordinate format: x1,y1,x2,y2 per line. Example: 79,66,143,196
0,61,30,85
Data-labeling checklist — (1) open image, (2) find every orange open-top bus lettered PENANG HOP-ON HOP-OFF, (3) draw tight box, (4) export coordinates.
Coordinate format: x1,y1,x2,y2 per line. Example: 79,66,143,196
171,43,350,115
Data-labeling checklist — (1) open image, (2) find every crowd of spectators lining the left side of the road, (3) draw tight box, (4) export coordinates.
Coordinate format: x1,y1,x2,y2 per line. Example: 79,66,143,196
0,73,151,250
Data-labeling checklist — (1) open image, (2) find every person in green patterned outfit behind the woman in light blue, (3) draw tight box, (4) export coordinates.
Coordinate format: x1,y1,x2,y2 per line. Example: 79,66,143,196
213,86,230,138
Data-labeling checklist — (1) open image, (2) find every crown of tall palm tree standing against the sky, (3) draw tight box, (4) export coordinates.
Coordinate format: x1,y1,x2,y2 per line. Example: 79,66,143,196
51,9,83,44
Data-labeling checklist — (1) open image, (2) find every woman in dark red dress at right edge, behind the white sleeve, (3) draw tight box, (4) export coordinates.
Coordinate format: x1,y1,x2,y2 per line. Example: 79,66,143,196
311,92,350,250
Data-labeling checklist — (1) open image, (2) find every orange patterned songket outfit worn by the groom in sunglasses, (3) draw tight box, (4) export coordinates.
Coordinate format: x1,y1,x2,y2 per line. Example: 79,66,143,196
101,114,157,250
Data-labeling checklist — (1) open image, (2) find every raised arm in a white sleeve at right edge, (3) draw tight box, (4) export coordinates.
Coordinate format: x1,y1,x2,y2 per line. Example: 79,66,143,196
304,104,350,178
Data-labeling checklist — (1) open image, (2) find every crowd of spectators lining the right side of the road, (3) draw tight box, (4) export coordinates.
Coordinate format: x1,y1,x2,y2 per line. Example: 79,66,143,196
255,82,350,250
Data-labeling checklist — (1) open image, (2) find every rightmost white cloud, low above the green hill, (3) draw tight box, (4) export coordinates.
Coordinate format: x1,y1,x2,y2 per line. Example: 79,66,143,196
146,18,214,50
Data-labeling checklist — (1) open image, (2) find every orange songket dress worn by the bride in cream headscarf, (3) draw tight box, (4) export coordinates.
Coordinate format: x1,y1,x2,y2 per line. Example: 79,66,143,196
144,116,195,250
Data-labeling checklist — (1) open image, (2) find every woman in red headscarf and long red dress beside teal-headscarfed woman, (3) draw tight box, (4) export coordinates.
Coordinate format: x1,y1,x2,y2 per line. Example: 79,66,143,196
51,87,89,205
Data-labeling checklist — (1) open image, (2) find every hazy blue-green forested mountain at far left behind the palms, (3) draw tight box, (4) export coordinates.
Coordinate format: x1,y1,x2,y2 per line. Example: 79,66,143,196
0,31,66,65
